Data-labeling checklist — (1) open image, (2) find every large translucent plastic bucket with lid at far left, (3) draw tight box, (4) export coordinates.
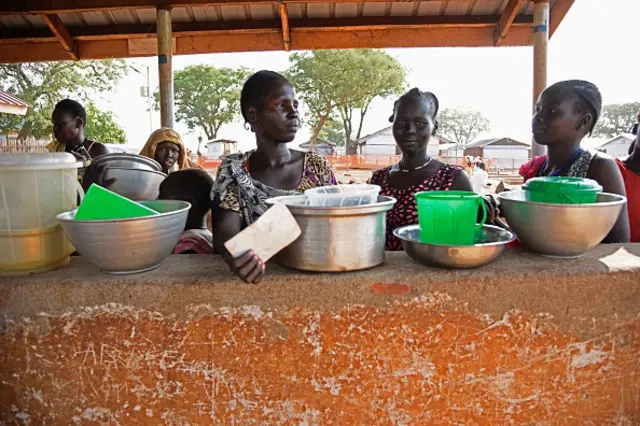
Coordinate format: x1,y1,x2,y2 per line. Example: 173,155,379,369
0,153,84,275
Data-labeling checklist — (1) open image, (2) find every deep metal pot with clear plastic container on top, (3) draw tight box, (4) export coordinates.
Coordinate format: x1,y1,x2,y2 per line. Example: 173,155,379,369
267,195,396,272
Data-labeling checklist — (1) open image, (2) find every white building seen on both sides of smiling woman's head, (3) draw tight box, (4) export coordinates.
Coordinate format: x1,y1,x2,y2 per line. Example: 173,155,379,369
356,126,463,157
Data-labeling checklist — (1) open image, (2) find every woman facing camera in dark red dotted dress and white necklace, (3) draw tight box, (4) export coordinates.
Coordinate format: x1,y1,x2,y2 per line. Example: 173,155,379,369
371,88,473,250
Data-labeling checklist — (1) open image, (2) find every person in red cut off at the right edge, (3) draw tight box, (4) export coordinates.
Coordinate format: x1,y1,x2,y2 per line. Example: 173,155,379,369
616,129,640,243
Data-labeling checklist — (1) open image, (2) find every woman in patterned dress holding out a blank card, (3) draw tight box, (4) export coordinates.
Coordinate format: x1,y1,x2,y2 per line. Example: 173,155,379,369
211,71,336,283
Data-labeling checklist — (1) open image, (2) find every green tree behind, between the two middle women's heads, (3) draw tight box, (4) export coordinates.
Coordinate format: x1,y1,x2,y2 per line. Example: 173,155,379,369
287,49,406,154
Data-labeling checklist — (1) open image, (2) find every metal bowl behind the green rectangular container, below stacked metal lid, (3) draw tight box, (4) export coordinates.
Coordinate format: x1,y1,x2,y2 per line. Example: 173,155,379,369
105,167,167,201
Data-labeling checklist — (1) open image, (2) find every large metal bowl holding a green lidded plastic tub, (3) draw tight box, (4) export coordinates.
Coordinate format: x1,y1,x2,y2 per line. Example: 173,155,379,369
500,191,627,258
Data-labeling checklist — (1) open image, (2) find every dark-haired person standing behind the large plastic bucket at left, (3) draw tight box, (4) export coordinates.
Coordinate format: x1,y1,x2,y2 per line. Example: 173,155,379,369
46,99,109,163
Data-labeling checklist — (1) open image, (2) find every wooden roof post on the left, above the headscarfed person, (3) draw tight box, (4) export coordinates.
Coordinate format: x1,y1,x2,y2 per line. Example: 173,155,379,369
156,7,174,128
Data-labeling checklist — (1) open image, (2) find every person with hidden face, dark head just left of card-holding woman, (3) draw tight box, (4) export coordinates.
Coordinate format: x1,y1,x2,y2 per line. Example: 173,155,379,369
158,169,213,254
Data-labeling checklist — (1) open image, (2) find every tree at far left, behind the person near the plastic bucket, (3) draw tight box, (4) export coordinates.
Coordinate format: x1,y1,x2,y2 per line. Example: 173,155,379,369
0,59,127,139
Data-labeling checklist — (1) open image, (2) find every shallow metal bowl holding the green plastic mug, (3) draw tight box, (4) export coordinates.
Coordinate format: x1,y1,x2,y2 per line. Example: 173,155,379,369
393,225,516,269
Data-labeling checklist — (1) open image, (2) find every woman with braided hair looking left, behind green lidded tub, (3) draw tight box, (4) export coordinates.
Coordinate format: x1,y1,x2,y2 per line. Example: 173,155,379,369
520,80,629,243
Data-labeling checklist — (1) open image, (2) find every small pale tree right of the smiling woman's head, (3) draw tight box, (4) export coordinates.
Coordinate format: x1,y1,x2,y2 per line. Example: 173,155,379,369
438,108,491,145
